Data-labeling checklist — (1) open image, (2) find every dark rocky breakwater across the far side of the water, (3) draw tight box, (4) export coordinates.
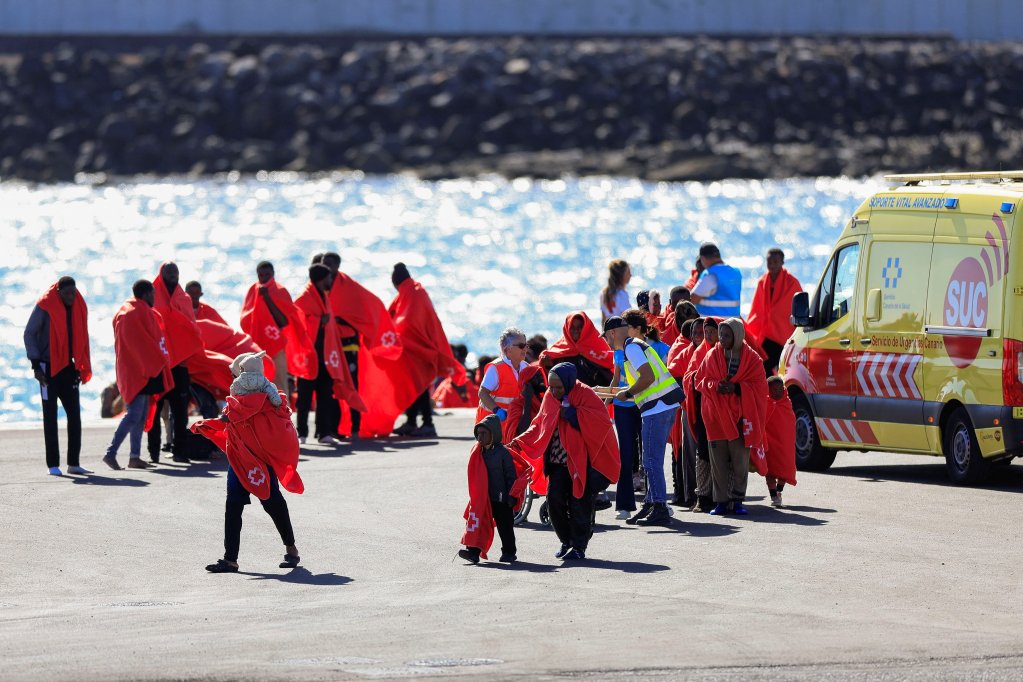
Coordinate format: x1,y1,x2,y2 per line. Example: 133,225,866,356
0,38,1023,181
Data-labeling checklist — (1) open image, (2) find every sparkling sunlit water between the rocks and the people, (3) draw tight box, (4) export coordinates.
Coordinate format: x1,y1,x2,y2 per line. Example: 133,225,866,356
0,174,882,422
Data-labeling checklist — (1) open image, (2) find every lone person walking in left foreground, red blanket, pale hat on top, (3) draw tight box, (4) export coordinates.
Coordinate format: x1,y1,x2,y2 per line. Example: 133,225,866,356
191,354,305,573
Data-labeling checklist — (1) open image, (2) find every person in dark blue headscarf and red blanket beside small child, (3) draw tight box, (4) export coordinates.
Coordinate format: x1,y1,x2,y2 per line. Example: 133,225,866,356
508,363,621,561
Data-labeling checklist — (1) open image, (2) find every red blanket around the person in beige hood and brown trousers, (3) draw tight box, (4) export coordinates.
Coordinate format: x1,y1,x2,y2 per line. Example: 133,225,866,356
694,344,767,475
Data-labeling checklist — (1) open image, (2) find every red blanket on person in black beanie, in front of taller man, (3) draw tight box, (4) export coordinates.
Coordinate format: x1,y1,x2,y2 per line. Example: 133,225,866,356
288,282,366,412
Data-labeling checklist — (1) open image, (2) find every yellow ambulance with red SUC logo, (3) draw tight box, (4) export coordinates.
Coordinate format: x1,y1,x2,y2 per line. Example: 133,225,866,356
781,171,1023,484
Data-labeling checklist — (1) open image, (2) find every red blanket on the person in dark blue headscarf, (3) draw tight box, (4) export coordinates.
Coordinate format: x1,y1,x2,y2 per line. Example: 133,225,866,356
508,384,617,498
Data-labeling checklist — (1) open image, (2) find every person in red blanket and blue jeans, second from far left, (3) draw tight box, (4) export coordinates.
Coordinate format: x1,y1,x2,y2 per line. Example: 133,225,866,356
103,279,174,470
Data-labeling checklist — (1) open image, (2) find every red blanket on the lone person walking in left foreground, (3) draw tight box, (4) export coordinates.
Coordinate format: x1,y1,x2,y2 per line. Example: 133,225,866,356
191,393,305,500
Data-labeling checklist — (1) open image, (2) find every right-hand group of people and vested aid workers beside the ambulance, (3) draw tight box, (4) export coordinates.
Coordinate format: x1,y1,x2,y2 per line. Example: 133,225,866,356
459,243,801,563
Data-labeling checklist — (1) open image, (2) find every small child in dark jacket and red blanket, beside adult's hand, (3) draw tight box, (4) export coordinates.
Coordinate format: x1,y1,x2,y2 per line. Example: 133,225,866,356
458,414,518,563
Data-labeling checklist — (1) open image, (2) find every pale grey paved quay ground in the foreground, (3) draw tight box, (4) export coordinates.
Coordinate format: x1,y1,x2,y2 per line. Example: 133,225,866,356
0,413,1023,680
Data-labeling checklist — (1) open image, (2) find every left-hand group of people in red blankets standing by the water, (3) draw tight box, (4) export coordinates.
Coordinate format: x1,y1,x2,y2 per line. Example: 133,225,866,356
25,253,465,475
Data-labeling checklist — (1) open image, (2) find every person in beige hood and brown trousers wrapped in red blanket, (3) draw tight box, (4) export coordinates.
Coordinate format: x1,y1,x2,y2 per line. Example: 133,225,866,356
694,317,767,515
